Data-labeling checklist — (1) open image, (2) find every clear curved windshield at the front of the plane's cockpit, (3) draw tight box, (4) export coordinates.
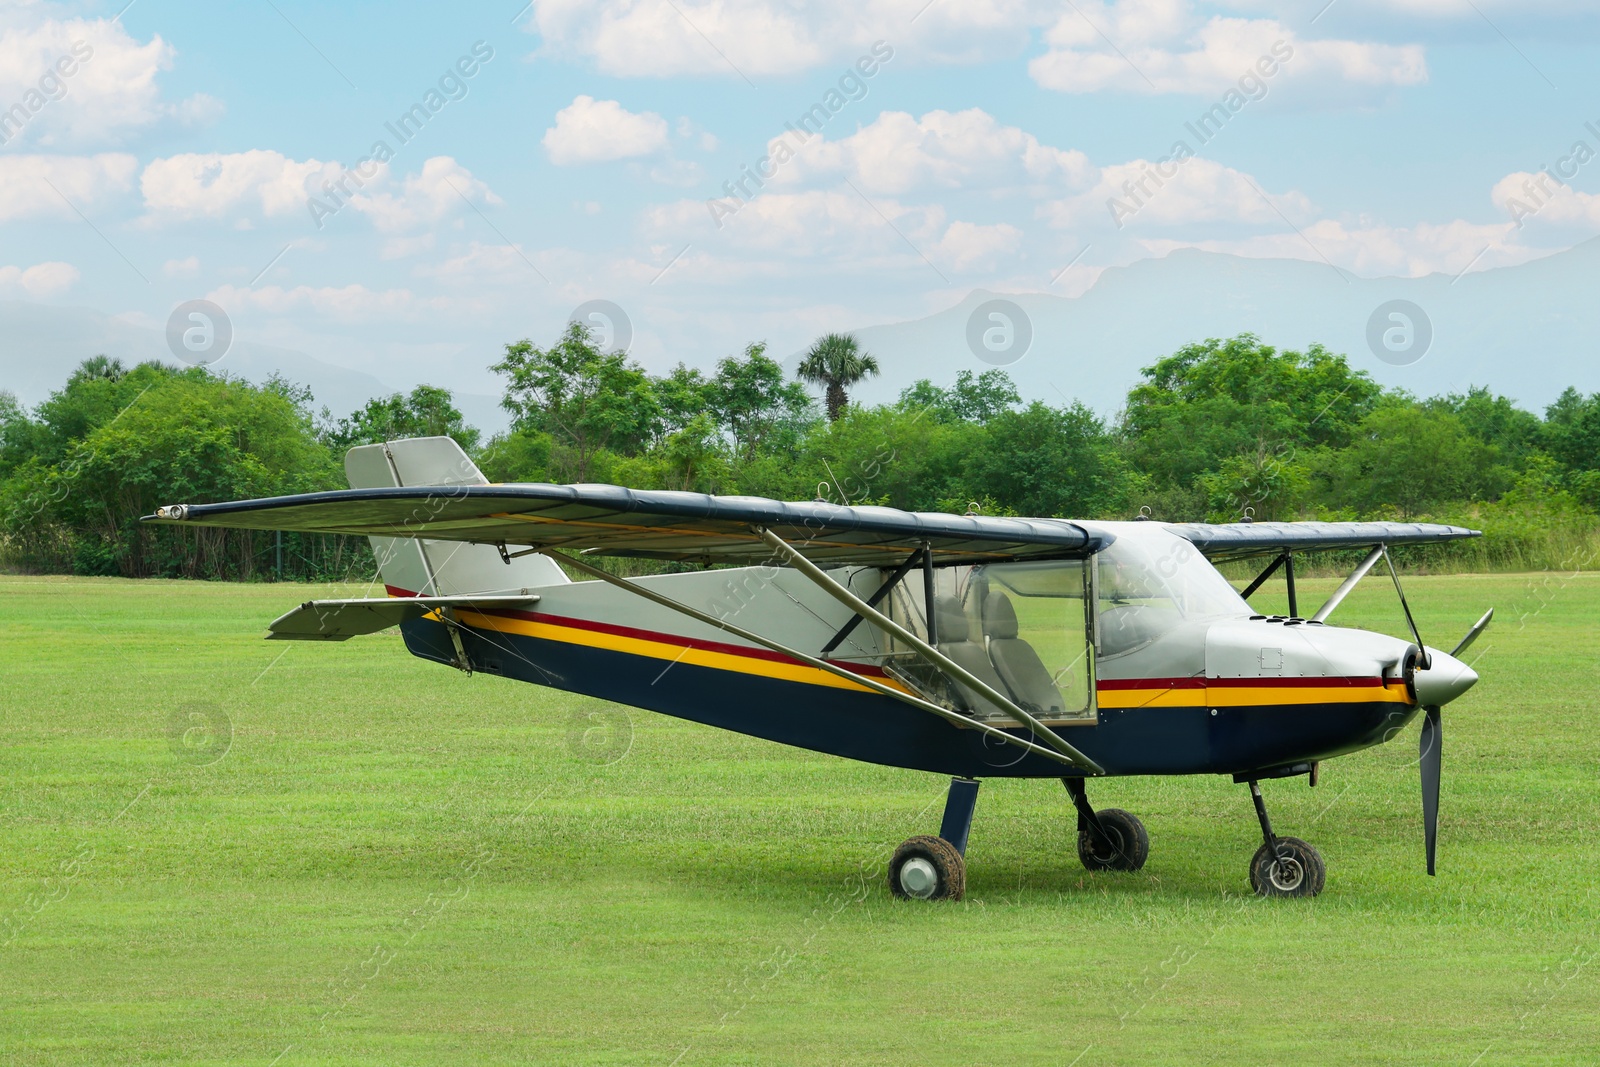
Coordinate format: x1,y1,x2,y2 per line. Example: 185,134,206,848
1096,523,1253,656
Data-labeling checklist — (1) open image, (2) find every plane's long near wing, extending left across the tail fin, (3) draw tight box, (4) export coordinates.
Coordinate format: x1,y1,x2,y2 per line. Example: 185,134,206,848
144,485,1112,566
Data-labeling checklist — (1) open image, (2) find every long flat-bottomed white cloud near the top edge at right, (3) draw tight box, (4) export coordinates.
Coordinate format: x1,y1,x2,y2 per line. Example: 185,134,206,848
1027,0,1427,94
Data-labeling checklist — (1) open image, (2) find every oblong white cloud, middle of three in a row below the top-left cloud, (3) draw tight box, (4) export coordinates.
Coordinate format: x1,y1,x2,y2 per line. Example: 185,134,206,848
139,149,341,219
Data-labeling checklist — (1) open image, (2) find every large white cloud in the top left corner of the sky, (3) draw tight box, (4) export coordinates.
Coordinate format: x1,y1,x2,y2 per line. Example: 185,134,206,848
0,19,222,146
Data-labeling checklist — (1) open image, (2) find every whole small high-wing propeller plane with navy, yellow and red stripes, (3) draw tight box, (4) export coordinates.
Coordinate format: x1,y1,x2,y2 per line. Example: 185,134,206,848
147,437,1493,899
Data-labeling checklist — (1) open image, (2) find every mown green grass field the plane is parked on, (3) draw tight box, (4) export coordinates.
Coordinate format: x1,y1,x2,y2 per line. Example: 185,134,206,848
0,574,1600,1067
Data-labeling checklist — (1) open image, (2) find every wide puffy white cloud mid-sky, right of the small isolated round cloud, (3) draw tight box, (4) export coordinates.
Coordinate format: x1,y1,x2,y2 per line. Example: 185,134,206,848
768,107,1094,195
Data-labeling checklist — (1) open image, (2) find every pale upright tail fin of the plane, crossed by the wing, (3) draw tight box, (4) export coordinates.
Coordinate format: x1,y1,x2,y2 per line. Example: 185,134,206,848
344,437,568,597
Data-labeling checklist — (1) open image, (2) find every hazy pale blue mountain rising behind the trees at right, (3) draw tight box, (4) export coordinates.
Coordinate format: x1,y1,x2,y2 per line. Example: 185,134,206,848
825,238,1600,414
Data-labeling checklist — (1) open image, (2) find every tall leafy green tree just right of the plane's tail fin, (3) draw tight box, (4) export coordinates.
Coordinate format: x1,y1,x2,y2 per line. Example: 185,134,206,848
490,323,661,482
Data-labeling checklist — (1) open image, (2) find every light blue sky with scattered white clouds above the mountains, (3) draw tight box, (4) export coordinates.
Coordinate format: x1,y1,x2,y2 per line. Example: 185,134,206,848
0,0,1600,412
